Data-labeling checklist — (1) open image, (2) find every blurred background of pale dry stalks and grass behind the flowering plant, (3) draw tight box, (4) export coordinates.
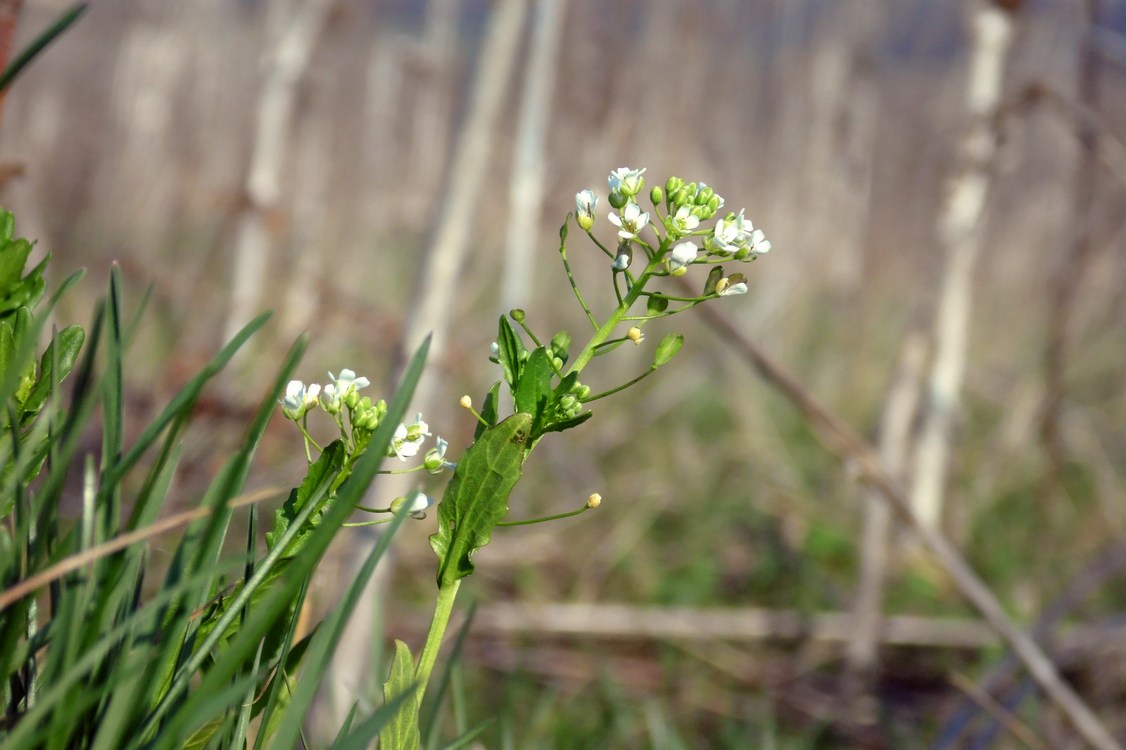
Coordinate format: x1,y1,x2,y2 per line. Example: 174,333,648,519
0,0,1126,748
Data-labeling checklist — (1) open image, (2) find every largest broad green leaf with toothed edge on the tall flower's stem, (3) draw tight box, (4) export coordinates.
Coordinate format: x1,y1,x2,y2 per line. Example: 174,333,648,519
430,412,531,587
